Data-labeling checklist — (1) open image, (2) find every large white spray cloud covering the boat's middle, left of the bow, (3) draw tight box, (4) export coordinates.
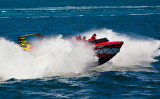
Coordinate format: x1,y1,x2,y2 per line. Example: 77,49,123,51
0,37,95,80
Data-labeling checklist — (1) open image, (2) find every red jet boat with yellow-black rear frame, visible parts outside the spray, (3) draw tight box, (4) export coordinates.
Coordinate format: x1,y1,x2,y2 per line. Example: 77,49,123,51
18,34,124,67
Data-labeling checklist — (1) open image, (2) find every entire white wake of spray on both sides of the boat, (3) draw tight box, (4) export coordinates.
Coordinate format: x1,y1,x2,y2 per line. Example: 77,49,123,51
0,29,160,80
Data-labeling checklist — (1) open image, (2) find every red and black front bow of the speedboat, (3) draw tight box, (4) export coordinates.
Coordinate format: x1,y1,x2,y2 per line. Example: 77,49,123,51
91,38,124,65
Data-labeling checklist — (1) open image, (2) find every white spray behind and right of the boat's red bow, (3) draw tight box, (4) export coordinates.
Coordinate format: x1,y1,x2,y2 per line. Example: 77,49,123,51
83,29,160,70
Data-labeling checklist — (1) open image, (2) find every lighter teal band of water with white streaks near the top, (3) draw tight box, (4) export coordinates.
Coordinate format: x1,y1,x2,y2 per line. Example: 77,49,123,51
0,6,160,18
